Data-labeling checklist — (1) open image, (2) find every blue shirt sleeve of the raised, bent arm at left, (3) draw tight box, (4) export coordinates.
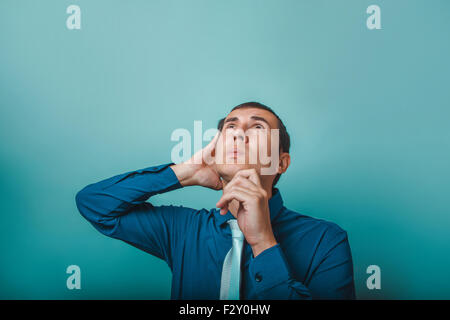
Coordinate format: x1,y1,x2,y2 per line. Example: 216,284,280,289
75,164,195,269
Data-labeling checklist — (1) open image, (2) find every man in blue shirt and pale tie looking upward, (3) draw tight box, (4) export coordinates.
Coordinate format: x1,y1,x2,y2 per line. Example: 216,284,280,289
76,102,355,300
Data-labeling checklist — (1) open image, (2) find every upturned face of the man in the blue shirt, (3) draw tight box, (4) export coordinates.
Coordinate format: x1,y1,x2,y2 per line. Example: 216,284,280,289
215,107,279,181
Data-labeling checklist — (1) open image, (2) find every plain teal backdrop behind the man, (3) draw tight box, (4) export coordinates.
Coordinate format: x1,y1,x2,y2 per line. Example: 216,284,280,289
0,0,450,299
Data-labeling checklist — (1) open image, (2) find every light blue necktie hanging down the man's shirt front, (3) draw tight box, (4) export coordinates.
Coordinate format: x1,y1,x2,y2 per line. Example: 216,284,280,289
220,219,244,300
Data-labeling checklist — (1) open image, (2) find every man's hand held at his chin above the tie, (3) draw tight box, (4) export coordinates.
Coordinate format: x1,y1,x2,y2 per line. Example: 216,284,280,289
216,169,277,257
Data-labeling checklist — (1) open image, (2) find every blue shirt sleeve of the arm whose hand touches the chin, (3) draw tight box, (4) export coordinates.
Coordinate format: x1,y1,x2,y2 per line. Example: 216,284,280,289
250,232,355,300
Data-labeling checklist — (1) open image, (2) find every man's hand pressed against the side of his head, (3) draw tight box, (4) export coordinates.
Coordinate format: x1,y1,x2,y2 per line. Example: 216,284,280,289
170,132,222,190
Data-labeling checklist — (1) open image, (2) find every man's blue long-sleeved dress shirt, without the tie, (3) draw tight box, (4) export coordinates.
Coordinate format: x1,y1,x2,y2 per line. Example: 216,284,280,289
76,164,355,300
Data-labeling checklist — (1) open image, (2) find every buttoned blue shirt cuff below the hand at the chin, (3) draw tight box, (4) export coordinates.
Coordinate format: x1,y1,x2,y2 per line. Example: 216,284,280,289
250,243,291,294
